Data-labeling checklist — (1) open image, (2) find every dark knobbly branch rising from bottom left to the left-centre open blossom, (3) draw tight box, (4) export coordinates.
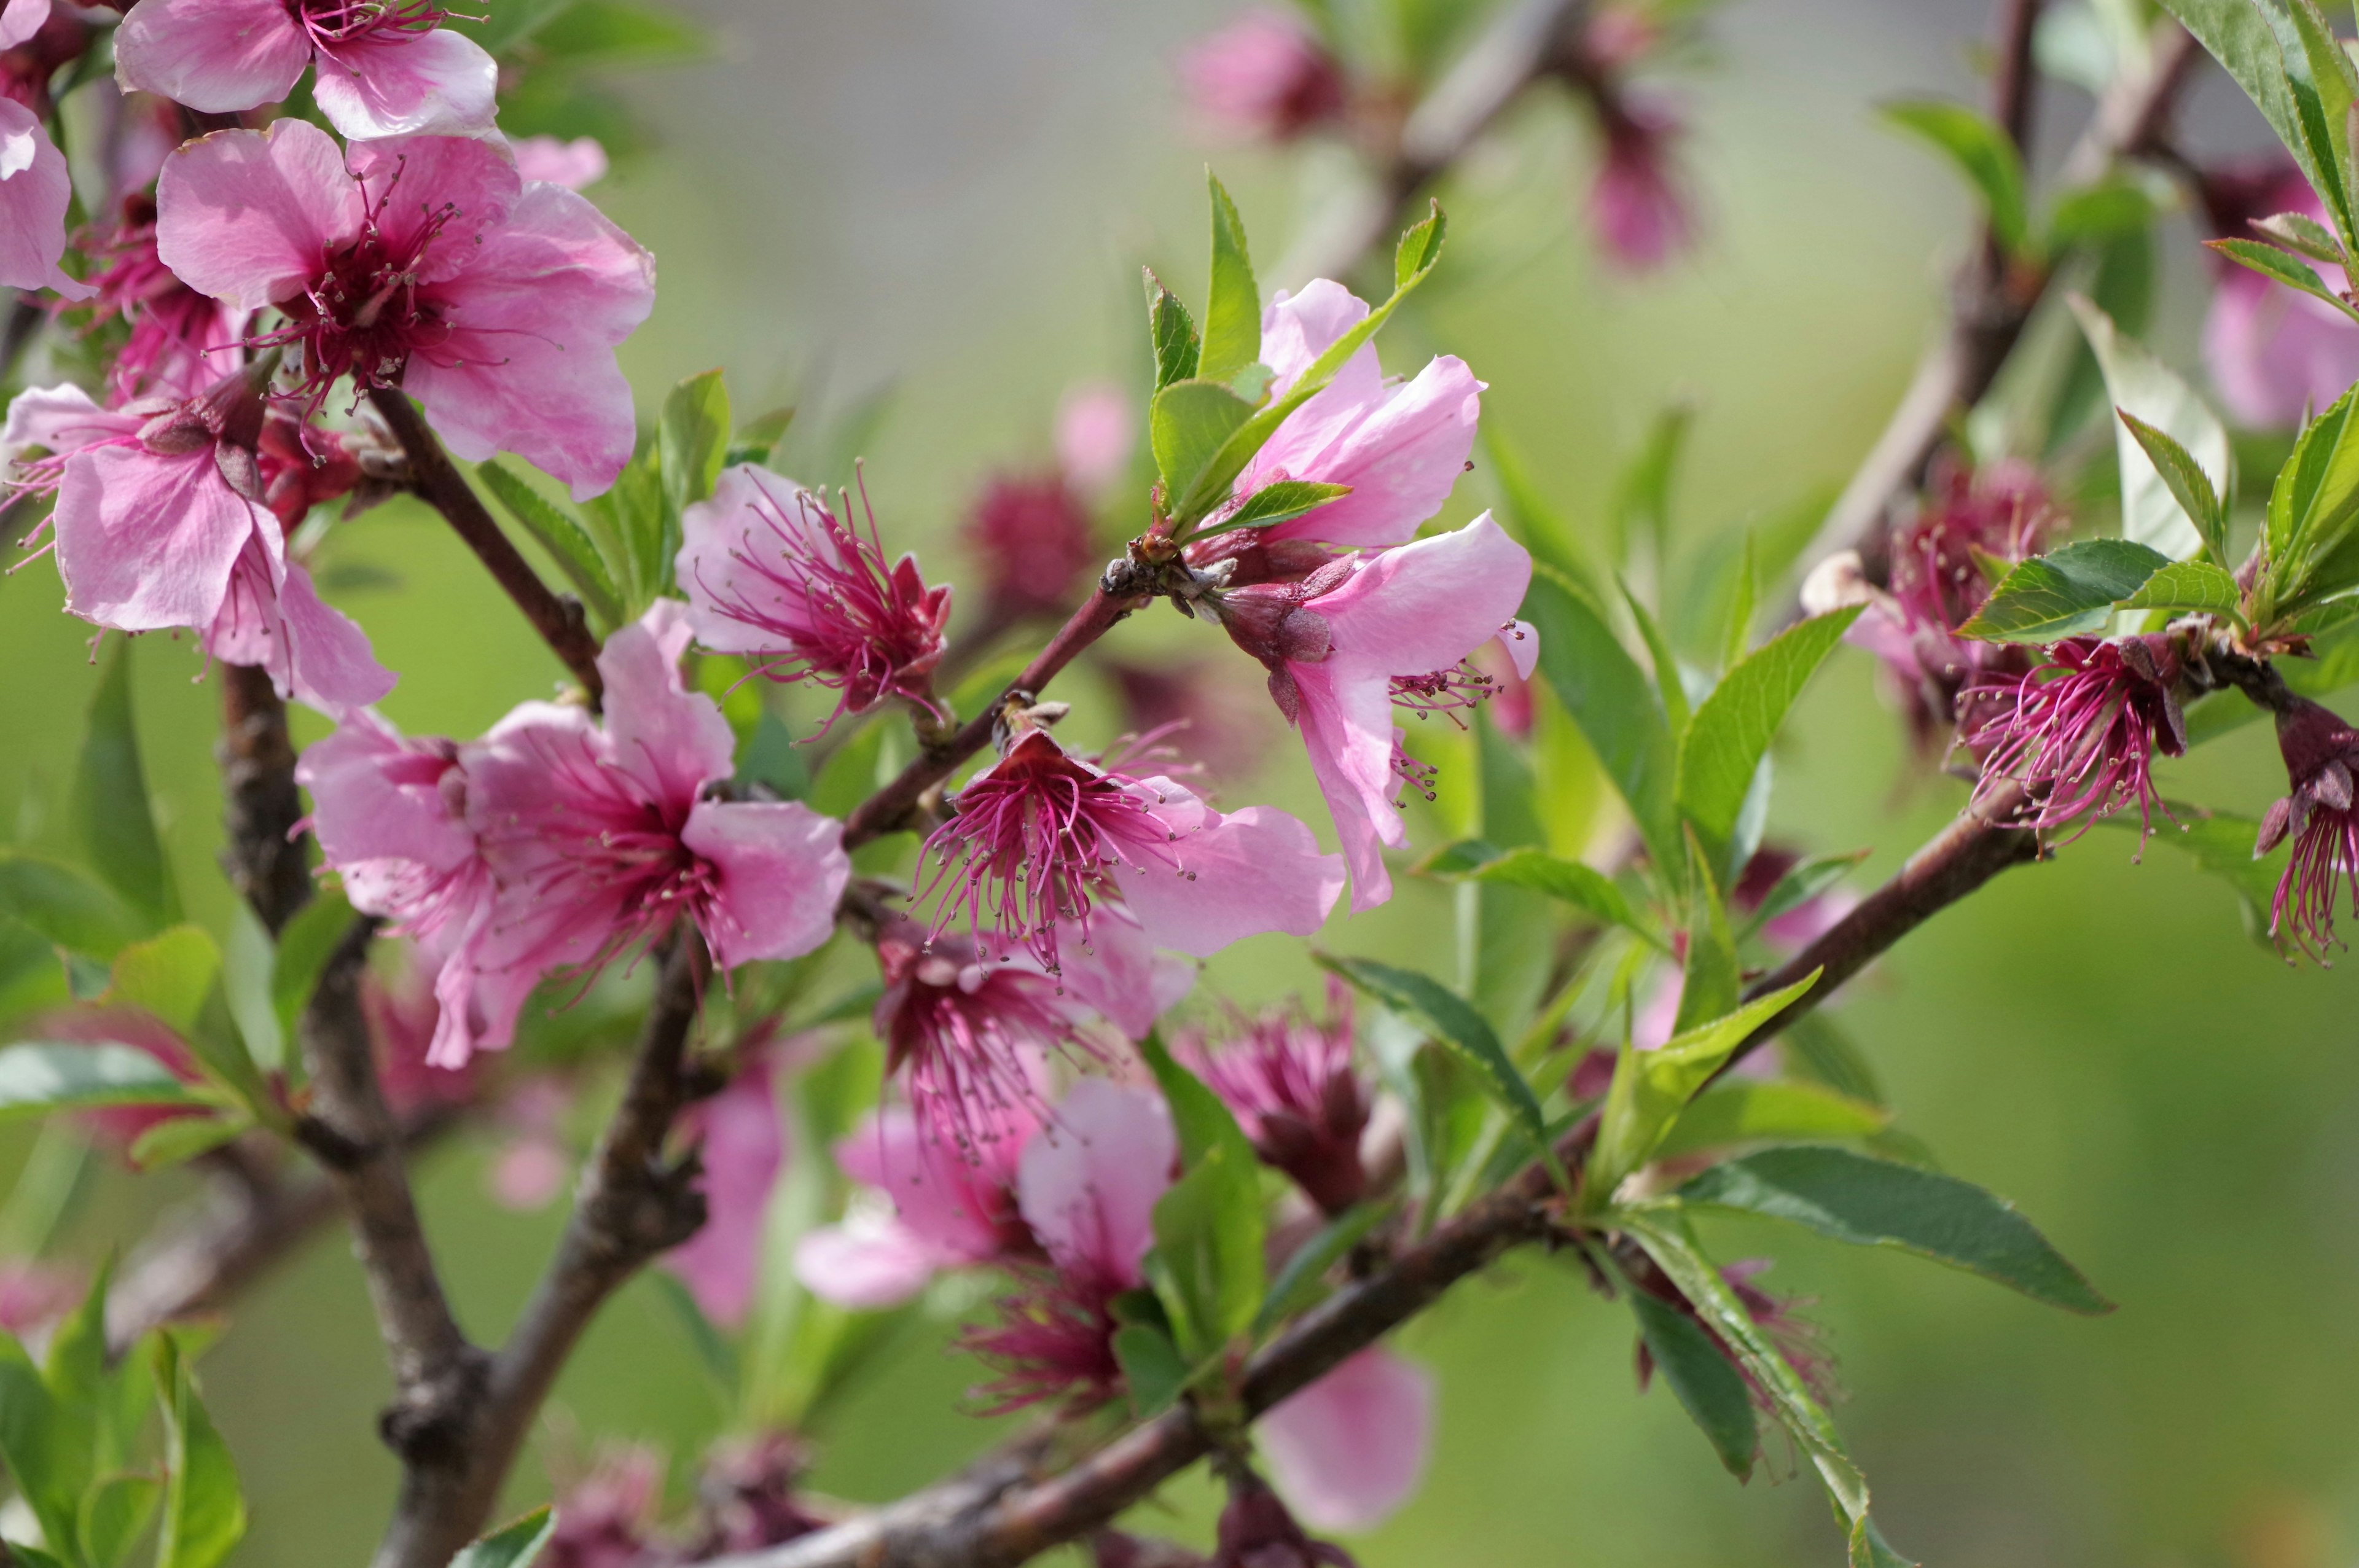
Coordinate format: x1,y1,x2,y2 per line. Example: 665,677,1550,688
375,931,710,1568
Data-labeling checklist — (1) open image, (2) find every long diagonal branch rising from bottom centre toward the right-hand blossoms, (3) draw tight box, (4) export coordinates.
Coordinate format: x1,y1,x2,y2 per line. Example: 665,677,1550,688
705,797,2038,1568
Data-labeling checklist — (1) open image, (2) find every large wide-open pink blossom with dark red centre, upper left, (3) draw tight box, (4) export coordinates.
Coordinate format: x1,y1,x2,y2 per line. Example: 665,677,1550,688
144,123,656,500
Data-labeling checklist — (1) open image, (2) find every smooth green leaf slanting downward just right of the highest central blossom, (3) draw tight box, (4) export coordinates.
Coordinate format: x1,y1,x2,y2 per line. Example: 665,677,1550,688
1524,564,1682,872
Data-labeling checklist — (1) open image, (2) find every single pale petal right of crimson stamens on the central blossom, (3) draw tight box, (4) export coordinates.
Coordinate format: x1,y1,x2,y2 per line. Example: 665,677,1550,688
1116,806,1345,958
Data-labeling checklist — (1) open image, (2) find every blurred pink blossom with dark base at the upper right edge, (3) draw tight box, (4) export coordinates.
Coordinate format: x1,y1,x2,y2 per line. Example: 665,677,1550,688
2204,163,2359,429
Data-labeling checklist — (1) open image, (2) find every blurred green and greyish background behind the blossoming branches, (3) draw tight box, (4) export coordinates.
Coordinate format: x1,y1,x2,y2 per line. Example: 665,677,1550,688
0,0,2359,1568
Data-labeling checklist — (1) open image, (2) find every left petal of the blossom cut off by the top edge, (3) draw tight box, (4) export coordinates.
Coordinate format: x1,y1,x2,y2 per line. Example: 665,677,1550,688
115,0,311,115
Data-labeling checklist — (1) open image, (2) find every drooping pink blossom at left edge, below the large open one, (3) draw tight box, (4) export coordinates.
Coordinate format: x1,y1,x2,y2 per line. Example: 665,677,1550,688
0,373,394,712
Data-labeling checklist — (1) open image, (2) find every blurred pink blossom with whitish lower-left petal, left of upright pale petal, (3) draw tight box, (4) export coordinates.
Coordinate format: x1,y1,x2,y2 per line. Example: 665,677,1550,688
795,1089,1038,1311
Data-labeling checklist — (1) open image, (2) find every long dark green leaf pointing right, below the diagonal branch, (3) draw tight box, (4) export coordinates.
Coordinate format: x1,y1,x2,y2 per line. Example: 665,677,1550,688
1680,1146,2114,1313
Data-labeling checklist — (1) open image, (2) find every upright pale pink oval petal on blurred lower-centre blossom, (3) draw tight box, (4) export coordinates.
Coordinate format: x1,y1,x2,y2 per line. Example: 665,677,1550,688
1017,1077,1180,1290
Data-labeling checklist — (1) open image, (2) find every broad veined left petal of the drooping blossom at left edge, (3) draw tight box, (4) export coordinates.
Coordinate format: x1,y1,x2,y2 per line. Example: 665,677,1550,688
57,446,260,632
